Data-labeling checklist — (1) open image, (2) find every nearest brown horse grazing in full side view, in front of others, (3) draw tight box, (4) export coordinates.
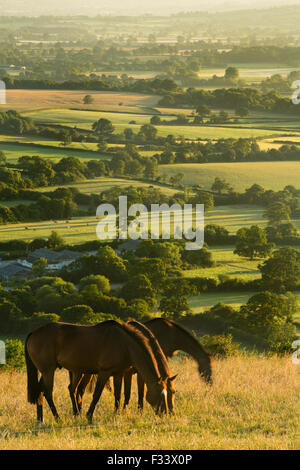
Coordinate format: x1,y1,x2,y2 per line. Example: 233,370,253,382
25,321,168,422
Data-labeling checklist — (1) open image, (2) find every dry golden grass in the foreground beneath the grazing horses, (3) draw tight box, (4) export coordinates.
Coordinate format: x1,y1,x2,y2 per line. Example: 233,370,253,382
0,356,300,450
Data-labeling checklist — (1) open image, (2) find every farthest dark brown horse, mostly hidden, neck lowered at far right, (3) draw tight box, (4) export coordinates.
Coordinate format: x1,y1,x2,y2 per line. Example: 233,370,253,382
77,318,213,414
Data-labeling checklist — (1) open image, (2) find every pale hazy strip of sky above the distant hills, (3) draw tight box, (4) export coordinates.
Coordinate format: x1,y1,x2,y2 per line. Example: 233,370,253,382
0,0,300,16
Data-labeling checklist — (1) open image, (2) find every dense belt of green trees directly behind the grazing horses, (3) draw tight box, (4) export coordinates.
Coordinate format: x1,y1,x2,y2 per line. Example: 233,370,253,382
0,235,300,351
